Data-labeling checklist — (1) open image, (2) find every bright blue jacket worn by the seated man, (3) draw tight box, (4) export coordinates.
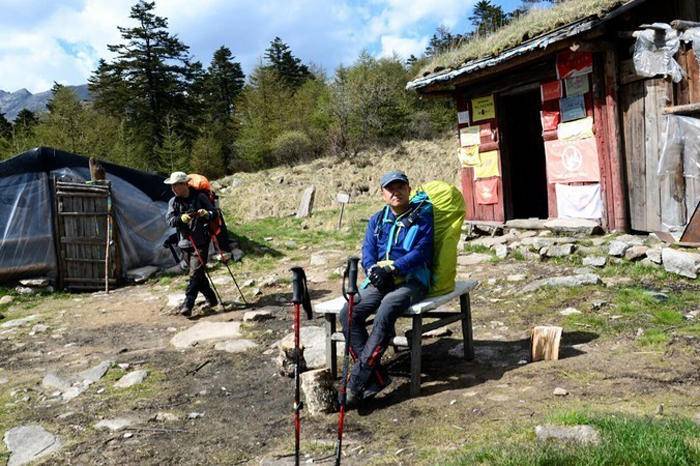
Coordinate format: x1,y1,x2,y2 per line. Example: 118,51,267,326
362,201,433,288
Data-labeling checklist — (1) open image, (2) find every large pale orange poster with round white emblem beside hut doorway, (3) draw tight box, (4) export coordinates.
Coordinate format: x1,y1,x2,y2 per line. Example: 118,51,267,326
544,138,600,183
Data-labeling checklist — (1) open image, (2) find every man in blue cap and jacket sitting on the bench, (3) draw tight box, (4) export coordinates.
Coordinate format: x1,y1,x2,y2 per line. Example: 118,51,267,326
340,171,433,406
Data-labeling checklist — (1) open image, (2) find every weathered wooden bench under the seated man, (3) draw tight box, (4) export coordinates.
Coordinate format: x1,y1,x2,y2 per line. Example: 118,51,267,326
314,280,478,396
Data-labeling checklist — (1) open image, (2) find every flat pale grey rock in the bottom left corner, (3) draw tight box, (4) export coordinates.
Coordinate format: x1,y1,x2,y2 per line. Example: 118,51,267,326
4,424,61,466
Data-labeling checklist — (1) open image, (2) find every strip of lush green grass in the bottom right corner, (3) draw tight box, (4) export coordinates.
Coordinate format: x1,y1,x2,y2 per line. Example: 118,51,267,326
447,411,700,466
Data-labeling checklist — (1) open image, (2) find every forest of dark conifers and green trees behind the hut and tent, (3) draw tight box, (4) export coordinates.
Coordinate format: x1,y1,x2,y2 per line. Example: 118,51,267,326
0,0,556,178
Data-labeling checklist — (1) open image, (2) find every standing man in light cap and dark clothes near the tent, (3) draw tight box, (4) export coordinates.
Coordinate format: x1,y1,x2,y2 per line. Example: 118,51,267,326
164,172,218,317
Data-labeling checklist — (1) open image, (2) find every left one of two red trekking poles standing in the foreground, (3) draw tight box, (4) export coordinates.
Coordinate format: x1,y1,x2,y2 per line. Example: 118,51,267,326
291,267,312,466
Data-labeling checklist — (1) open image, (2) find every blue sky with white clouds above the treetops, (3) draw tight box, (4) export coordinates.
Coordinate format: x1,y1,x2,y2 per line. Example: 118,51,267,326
0,0,532,92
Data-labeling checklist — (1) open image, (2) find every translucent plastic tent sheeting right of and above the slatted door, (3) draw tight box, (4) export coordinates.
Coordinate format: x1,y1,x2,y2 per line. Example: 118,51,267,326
51,167,174,271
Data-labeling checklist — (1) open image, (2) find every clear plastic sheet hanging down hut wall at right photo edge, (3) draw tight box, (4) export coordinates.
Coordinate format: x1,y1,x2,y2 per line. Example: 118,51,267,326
657,115,700,231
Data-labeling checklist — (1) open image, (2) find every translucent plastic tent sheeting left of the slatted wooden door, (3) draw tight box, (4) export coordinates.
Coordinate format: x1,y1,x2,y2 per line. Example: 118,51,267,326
0,172,56,280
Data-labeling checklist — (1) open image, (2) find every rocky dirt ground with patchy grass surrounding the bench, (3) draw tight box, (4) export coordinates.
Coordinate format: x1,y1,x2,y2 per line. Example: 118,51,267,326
0,201,700,465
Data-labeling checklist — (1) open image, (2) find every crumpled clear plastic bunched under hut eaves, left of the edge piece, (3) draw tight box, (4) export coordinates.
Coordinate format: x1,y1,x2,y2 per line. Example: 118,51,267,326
632,23,684,83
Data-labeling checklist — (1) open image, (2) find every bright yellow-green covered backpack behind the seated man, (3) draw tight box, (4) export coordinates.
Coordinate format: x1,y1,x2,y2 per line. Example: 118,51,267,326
415,180,465,296
